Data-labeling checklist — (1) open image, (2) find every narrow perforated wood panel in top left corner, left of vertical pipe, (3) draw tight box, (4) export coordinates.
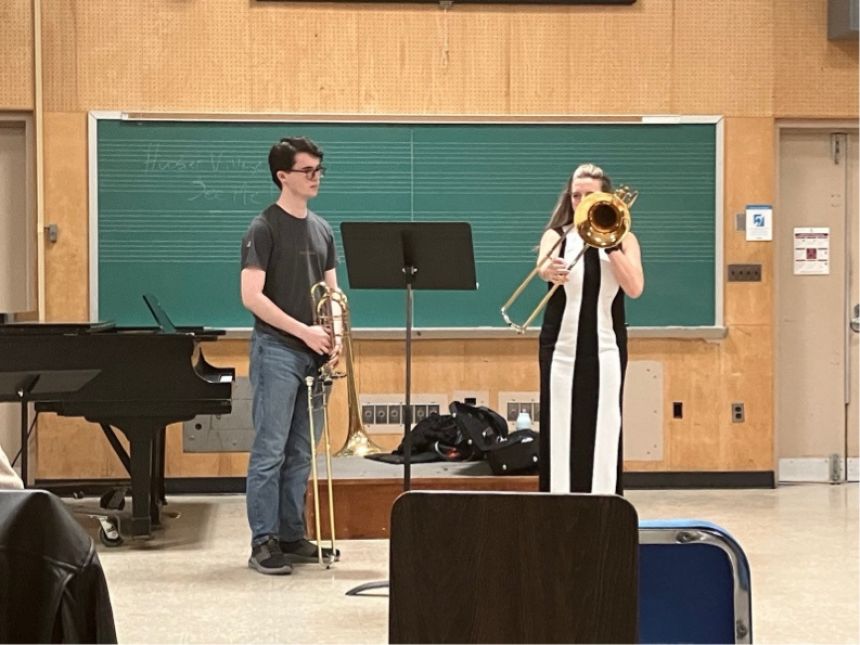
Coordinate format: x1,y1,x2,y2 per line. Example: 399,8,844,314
0,0,34,110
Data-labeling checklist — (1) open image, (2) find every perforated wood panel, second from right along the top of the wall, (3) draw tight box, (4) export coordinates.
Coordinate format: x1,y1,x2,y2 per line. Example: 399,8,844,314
670,0,772,115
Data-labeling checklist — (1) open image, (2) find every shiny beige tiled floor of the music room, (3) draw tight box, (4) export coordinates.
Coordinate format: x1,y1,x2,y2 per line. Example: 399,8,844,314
71,483,860,643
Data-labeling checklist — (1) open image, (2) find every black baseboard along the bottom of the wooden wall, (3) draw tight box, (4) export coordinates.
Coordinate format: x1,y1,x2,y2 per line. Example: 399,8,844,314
34,470,776,497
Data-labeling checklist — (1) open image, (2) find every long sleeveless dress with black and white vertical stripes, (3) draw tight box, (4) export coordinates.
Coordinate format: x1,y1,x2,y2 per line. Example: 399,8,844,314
540,231,627,495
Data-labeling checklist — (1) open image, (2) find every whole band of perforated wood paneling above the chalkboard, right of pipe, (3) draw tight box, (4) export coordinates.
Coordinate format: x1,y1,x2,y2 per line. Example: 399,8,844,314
30,0,857,117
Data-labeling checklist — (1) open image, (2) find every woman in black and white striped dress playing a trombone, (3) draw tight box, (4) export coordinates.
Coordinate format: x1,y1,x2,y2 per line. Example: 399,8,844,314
538,164,645,494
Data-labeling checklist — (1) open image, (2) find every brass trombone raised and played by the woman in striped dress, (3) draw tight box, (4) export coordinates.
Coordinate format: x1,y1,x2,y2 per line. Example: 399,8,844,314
501,186,639,334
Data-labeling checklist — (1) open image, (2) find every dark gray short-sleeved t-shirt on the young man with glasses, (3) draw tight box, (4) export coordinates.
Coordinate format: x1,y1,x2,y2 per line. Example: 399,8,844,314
242,204,337,353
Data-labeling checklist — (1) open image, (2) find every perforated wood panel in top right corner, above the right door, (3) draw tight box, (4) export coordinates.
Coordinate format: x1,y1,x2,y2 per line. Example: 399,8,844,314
770,0,858,119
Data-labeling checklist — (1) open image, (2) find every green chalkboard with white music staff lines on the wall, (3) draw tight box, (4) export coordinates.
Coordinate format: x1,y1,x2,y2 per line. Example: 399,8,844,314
91,118,719,329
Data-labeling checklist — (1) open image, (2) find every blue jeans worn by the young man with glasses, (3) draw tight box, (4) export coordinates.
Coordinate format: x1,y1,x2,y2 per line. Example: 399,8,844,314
246,331,322,545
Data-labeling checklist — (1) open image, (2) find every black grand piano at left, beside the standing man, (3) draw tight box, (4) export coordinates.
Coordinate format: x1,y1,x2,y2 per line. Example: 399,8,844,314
0,296,235,537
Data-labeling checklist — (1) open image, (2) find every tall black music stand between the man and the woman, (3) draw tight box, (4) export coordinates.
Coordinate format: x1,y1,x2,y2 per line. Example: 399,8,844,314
340,222,478,596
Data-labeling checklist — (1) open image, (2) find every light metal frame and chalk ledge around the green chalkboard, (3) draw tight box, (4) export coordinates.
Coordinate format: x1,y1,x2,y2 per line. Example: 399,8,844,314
88,111,726,339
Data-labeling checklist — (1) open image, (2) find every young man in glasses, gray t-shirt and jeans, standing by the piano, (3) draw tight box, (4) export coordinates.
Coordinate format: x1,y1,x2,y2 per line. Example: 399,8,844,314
241,137,340,574
